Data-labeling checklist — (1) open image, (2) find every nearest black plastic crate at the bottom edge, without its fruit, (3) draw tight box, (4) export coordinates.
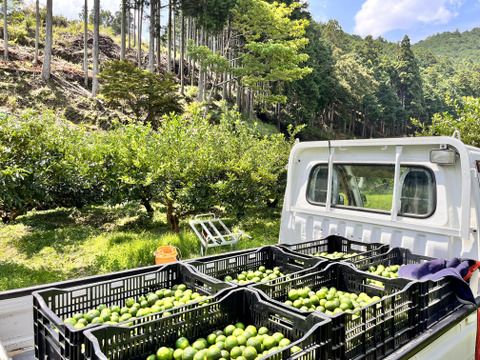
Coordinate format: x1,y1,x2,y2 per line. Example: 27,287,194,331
85,287,331,360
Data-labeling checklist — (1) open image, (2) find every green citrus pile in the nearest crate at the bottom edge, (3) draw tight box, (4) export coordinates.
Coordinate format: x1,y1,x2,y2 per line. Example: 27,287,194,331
147,322,301,360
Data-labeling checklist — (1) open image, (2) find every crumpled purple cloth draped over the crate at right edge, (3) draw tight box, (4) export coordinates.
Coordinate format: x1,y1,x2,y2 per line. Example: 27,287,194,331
398,258,475,303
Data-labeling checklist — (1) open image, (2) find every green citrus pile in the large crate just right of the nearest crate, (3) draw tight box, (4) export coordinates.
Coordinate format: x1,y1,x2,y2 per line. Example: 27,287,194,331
285,286,380,315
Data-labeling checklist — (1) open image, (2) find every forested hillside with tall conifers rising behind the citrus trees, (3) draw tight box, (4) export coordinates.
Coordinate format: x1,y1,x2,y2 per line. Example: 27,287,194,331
0,0,480,140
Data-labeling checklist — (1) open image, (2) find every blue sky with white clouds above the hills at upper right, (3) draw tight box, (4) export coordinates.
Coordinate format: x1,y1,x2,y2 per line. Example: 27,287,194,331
308,0,480,43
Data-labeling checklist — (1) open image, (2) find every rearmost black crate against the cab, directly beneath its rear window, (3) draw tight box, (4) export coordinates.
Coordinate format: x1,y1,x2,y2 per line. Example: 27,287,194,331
279,235,389,262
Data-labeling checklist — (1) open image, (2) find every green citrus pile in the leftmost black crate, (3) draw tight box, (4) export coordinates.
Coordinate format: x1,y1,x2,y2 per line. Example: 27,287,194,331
63,284,208,329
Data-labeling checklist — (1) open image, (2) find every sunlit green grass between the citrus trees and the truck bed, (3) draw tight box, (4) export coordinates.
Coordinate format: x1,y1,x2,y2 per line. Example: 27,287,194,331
0,203,280,291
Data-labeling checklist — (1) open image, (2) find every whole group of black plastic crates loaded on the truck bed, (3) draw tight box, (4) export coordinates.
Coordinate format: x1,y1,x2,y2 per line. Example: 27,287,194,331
34,236,476,360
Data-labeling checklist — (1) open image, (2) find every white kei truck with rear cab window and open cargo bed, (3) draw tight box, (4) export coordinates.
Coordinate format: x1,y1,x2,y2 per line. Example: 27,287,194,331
0,136,480,360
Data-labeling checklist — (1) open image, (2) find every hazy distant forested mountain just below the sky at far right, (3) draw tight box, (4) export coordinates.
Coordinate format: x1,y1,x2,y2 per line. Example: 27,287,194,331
412,28,480,62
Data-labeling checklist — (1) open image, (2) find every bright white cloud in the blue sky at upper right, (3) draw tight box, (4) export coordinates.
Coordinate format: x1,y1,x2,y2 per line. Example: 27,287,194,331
355,0,462,37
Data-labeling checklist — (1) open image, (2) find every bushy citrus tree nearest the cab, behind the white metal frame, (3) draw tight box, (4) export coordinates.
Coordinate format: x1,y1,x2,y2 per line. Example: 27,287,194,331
157,106,293,231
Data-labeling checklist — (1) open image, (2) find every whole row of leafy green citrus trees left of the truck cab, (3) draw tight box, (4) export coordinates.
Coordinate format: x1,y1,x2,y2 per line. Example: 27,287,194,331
0,104,293,232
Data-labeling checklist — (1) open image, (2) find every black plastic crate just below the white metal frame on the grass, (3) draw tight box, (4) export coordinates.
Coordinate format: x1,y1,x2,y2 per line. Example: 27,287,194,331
187,245,326,285
